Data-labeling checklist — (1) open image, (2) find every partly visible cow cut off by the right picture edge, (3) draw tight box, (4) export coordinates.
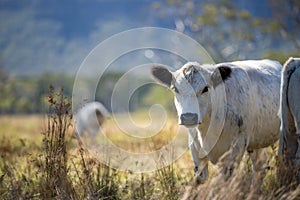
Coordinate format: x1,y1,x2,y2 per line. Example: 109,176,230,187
279,58,300,185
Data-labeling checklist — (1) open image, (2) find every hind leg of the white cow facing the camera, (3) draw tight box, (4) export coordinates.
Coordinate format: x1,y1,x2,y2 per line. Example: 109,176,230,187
249,149,267,190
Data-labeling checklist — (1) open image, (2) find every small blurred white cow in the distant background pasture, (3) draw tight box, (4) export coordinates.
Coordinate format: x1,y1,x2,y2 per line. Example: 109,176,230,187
75,102,109,138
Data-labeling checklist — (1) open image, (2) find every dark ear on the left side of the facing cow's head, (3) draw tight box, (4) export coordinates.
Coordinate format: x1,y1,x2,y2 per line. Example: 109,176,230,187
151,66,173,87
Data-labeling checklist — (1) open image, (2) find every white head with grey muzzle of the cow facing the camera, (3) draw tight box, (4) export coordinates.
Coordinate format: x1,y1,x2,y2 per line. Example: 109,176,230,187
151,62,230,128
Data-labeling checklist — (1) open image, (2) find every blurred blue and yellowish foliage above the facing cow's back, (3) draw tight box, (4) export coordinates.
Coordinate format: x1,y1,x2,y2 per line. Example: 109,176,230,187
155,0,300,63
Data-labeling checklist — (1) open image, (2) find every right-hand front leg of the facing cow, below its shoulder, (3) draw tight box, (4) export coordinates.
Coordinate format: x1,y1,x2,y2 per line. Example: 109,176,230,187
221,133,247,180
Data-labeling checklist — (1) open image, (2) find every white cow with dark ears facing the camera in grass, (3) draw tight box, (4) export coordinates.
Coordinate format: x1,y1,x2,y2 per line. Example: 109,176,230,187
151,60,282,183
